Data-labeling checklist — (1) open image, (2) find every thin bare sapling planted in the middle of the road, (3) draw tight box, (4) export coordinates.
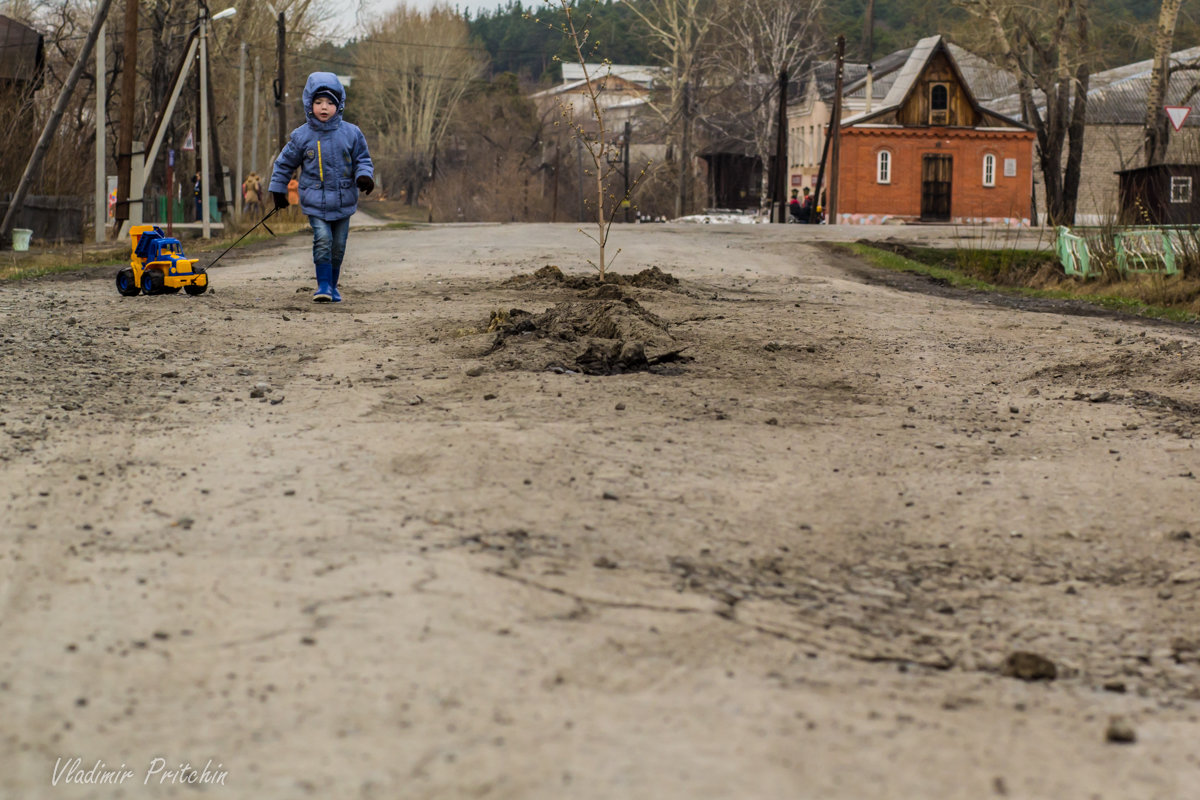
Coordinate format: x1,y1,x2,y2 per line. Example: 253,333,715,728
534,0,650,281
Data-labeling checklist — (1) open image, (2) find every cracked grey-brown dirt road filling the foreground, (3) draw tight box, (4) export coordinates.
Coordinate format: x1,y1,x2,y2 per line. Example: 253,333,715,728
0,225,1200,800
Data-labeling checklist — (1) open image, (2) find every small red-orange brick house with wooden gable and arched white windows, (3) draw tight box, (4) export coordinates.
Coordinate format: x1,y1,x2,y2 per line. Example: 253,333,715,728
830,36,1033,225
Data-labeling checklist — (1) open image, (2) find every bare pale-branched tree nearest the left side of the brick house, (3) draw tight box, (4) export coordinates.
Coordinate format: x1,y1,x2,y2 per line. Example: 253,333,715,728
714,0,823,215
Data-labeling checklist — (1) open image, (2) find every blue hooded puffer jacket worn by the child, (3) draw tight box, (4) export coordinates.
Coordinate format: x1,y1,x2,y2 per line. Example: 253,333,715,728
268,72,374,221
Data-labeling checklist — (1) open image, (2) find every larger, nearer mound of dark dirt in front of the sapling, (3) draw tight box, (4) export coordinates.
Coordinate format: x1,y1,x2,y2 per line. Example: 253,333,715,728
487,297,689,375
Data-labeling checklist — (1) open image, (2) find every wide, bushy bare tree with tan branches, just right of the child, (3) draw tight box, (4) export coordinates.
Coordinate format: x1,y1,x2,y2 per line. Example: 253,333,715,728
354,2,485,205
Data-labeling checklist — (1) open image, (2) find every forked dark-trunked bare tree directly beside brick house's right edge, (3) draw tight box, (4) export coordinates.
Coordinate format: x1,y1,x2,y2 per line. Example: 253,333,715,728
958,0,1091,224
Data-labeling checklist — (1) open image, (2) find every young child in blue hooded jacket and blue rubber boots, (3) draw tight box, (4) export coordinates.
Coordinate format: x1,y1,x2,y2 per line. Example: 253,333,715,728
269,72,374,302
